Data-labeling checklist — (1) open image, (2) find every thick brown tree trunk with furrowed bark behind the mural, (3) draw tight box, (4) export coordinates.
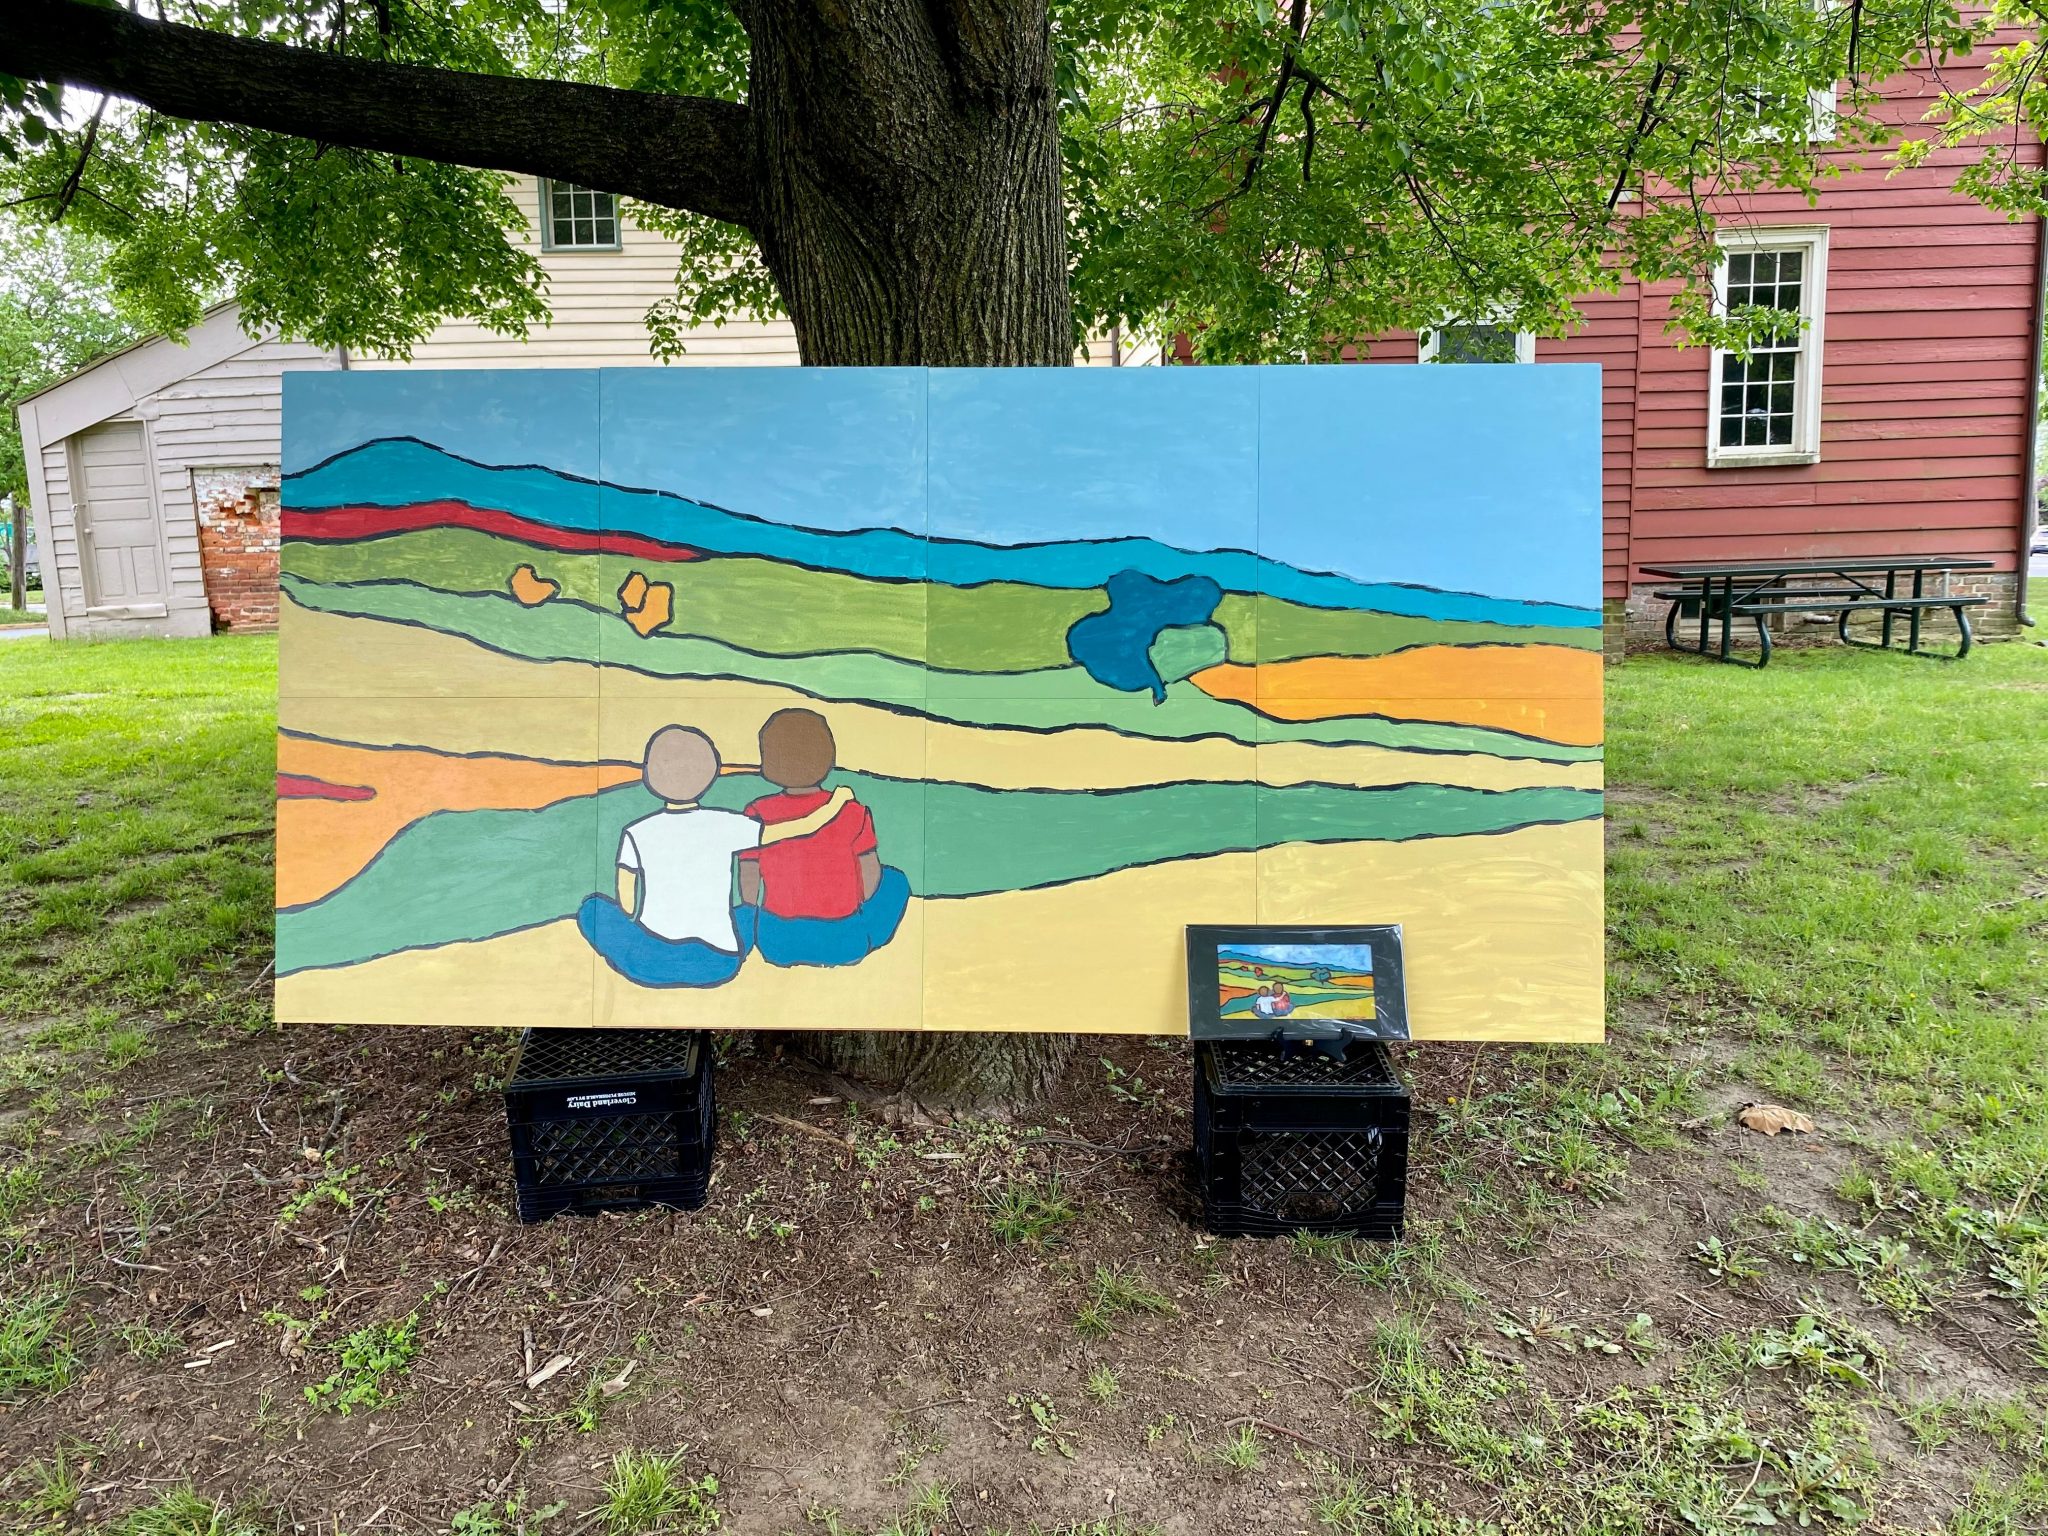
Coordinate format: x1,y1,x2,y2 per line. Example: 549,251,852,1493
741,0,1073,1108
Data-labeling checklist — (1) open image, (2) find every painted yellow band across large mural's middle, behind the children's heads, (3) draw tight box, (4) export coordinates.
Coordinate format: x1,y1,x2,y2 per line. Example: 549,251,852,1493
279,600,1602,788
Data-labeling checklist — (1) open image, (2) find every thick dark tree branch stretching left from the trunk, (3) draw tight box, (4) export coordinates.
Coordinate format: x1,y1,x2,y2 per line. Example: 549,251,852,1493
0,0,754,227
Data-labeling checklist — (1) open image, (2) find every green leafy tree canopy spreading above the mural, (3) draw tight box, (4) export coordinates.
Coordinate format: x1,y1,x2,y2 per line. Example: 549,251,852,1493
0,0,2048,360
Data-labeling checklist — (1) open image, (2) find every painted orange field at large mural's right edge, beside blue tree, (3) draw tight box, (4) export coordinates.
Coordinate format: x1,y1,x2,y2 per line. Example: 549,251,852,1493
1190,645,1602,748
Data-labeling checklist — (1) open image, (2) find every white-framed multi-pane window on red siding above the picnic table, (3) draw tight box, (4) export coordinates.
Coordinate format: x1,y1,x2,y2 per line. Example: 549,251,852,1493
1708,231,1827,463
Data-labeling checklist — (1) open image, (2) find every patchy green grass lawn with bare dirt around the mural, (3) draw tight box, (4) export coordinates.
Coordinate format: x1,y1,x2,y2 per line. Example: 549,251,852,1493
0,639,2048,1536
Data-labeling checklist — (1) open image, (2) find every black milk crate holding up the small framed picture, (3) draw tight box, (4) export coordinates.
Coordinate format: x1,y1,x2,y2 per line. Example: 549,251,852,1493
1194,1040,1409,1241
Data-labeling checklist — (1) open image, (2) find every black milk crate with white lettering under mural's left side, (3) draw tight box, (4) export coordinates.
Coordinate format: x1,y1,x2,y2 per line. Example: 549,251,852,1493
506,1028,719,1221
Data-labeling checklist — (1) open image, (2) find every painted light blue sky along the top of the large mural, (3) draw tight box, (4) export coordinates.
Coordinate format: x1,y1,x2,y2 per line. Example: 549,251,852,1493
285,365,1599,606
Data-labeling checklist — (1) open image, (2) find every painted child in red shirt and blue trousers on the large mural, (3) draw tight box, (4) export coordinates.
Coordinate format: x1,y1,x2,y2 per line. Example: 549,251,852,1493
737,709,909,965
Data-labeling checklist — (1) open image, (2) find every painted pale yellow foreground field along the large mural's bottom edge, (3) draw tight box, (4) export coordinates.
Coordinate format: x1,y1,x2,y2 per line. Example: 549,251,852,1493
276,823,1604,1040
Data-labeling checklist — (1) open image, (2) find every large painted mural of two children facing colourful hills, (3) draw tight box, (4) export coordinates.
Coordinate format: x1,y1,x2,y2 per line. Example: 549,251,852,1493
276,367,1602,1040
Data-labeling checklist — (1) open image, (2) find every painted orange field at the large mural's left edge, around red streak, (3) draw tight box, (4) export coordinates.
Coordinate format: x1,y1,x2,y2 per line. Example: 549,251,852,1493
276,735,639,907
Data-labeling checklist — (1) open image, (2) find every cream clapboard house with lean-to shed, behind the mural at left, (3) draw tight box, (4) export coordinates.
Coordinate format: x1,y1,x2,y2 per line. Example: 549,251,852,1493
20,178,1159,639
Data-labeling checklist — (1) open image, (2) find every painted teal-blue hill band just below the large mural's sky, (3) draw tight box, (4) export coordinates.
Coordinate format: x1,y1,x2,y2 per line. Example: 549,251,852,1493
283,438,1599,629
